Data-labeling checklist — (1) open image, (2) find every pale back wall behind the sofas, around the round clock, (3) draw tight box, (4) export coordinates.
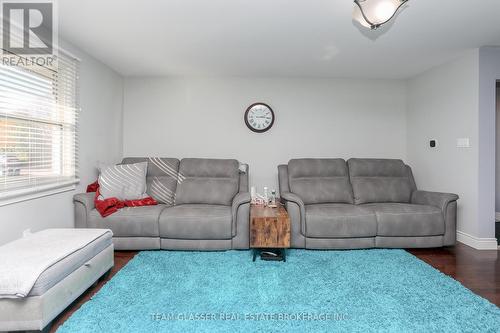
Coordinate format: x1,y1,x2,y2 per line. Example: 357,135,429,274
123,78,406,191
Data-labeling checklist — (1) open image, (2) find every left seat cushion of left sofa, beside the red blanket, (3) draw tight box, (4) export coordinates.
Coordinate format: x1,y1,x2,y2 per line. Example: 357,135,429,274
88,205,167,237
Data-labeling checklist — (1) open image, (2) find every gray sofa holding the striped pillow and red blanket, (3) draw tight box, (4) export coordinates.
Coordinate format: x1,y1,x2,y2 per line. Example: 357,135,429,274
73,158,250,250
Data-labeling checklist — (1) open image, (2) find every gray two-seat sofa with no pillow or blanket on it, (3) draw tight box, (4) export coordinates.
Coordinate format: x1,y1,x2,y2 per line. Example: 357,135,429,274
278,158,458,249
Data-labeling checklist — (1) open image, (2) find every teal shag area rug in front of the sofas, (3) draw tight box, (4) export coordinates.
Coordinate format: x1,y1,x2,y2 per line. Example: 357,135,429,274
58,249,500,333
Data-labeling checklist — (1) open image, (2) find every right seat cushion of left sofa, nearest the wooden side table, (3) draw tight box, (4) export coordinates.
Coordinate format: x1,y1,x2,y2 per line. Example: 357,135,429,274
159,204,232,239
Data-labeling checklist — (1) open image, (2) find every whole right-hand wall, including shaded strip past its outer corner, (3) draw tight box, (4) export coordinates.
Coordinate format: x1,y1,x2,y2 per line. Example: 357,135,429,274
407,48,500,244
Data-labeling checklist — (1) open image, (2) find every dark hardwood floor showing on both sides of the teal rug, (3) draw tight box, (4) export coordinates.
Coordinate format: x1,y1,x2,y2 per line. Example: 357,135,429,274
50,243,500,332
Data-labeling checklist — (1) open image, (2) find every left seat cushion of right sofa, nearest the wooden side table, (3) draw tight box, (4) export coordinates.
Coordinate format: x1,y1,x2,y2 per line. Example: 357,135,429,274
306,204,377,238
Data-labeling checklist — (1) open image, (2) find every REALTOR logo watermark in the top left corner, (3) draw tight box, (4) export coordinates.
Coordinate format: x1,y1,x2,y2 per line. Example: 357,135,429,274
0,0,57,66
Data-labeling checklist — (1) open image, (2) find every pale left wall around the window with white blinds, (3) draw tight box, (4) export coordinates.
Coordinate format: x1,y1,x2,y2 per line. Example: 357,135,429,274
0,43,123,245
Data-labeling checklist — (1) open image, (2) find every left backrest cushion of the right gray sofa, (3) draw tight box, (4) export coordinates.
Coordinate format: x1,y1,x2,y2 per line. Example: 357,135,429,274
288,158,353,205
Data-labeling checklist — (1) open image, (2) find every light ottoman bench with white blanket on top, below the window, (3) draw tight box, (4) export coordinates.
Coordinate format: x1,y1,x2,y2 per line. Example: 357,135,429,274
0,229,114,331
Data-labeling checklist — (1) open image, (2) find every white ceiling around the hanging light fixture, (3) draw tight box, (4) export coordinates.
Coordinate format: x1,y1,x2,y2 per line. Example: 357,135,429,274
59,0,500,78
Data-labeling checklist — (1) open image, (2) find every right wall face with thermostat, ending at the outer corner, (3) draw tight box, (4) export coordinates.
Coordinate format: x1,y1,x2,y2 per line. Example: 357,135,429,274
407,50,479,235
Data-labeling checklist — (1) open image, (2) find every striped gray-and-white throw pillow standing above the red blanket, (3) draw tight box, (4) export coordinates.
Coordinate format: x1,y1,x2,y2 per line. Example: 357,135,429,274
99,162,148,200
